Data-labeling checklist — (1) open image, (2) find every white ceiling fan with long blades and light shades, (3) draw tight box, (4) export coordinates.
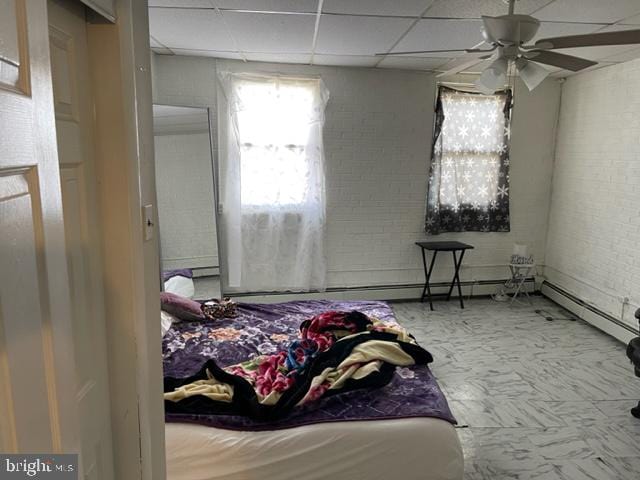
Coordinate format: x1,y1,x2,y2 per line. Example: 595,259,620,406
377,0,640,93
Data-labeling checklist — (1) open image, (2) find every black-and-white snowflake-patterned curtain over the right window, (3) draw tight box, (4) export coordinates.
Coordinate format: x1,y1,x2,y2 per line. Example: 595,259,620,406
425,86,512,234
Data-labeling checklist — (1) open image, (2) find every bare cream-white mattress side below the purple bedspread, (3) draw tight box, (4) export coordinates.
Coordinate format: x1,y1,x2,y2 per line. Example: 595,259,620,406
165,418,463,480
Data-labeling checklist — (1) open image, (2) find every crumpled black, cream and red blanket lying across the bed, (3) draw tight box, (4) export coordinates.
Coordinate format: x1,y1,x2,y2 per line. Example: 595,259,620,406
165,311,433,421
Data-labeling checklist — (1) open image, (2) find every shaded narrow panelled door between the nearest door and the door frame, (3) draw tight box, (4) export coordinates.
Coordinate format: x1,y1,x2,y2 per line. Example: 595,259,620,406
48,0,113,480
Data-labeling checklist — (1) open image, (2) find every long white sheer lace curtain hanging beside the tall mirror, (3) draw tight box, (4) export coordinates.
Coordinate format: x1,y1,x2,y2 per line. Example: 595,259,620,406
219,72,329,292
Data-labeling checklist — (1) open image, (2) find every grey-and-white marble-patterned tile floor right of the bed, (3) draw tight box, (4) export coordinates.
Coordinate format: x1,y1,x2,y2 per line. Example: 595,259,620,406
392,297,640,480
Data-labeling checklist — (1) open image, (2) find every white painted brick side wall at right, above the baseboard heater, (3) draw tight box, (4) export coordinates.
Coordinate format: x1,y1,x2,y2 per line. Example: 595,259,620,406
545,60,640,326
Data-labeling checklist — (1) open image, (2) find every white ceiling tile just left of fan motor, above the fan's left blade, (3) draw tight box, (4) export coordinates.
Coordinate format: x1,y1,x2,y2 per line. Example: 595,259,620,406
393,19,482,57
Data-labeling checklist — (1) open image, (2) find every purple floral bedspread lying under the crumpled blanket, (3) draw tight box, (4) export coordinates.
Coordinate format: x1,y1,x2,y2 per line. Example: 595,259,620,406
162,300,455,431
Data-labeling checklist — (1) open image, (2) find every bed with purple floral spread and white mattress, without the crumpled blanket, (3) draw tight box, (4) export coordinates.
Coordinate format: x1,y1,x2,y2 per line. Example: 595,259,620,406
163,301,463,480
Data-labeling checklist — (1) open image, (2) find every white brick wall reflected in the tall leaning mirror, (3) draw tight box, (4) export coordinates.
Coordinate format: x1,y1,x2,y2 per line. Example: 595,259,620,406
154,133,218,270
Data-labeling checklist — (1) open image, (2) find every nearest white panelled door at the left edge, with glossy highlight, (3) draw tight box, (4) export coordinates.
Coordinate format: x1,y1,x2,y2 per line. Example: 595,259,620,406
0,0,79,453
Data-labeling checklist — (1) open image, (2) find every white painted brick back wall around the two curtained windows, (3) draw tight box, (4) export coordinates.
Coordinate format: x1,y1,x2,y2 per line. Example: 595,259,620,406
154,56,560,287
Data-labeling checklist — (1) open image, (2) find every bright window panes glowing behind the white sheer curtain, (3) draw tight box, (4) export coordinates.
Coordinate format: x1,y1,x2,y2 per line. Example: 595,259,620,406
237,81,314,207
